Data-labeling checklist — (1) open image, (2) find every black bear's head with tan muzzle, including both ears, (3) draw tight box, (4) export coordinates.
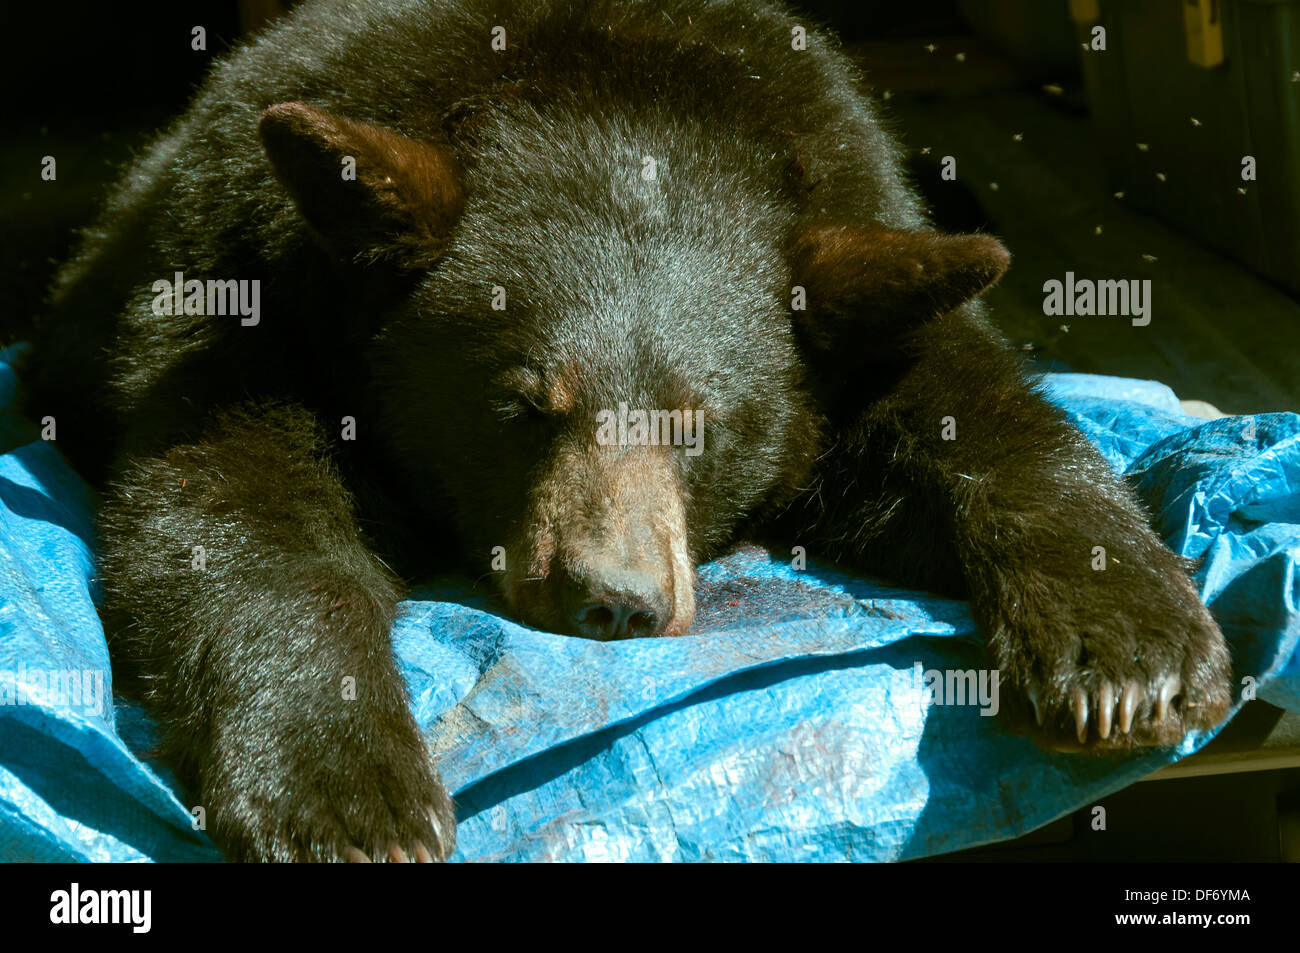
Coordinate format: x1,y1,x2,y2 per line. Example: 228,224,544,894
260,103,1008,638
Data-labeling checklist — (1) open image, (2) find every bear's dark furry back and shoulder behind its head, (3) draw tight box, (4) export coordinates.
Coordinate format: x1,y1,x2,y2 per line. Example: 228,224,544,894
33,0,923,483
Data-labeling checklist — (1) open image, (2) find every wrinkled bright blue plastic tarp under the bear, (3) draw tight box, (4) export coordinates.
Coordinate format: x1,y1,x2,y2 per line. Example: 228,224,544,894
0,345,1300,861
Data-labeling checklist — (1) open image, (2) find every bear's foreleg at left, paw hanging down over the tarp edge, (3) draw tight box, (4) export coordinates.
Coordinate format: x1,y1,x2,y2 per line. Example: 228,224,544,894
101,397,455,861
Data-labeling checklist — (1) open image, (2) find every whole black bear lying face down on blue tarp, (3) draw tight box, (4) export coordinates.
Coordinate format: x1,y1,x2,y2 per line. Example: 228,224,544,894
29,0,1230,861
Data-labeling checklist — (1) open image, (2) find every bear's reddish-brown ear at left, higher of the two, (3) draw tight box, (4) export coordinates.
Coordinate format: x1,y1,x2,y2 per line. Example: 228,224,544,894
257,103,464,269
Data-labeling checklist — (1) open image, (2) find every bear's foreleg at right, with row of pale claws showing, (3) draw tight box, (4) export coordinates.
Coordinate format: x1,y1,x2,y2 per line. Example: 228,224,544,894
802,308,1231,749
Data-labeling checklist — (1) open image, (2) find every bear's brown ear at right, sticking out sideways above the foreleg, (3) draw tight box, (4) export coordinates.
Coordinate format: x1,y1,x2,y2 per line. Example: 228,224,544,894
790,225,1011,356
